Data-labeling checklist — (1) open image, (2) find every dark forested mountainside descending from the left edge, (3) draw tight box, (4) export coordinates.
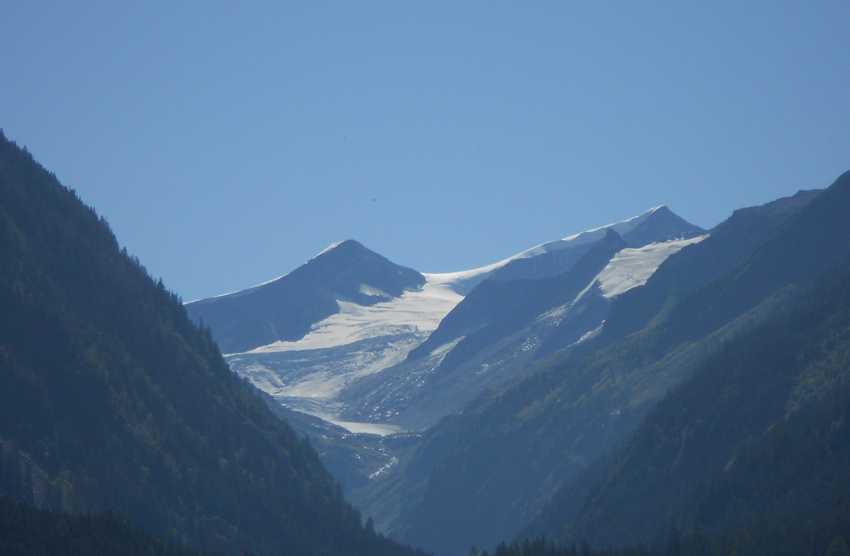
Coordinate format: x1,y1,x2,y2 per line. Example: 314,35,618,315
0,133,420,555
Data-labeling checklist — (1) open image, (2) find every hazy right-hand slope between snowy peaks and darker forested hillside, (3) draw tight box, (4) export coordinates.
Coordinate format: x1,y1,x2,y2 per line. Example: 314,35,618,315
388,177,850,554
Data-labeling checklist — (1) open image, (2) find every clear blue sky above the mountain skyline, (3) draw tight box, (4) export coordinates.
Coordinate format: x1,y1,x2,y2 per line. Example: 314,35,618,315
0,0,850,301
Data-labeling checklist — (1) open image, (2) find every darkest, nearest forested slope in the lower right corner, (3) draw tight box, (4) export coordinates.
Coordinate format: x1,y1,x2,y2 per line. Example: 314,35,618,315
526,245,850,553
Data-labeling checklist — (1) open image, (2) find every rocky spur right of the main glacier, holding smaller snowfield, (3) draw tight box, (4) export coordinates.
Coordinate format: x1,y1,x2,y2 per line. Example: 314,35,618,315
338,209,705,430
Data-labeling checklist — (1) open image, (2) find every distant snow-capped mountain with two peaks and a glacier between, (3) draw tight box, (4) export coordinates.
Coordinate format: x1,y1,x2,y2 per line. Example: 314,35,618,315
186,206,704,434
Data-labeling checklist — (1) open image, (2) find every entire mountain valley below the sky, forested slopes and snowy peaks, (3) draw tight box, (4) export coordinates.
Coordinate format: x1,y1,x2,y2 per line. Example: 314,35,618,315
0,128,850,556
